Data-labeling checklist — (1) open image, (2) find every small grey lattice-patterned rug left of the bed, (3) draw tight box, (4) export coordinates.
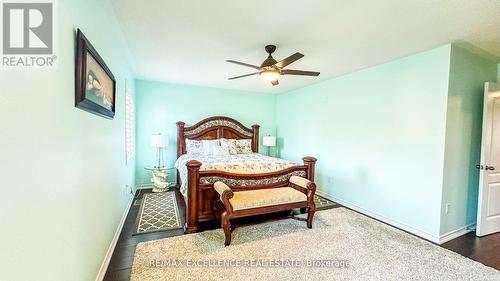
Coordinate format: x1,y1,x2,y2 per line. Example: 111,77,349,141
133,191,181,235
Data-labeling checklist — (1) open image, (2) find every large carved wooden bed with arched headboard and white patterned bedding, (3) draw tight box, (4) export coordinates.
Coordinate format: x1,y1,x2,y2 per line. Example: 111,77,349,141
175,116,316,233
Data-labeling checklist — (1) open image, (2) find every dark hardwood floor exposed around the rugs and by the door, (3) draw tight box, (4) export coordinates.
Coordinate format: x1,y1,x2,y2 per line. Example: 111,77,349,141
104,186,500,281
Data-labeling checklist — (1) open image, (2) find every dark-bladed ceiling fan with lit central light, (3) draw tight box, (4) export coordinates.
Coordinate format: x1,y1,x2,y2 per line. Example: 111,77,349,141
226,45,319,86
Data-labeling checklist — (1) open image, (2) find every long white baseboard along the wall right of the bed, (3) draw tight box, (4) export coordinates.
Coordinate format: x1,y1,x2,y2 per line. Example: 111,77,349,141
316,191,440,244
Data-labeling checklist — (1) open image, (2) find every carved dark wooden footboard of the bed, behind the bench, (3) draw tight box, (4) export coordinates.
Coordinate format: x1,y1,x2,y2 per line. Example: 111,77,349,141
184,157,316,233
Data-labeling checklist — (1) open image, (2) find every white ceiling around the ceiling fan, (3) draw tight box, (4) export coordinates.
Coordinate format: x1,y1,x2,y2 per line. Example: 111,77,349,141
111,0,500,93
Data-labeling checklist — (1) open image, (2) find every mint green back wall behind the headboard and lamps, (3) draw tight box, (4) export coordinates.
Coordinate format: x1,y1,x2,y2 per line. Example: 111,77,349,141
136,80,276,185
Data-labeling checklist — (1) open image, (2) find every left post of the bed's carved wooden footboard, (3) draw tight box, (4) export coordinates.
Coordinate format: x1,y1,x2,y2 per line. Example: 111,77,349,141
184,160,201,233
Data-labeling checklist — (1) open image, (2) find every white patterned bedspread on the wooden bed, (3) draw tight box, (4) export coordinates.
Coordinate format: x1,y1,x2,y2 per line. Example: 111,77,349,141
175,153,297,196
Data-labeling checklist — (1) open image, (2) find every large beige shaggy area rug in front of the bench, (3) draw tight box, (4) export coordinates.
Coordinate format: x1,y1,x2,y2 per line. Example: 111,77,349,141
131,207,500,281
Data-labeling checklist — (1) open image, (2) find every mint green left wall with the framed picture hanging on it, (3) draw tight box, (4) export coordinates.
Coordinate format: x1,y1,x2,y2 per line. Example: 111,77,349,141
0,0,134,281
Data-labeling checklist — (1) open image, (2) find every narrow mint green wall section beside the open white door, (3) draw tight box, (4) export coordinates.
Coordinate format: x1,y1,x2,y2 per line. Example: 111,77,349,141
441,45,498,234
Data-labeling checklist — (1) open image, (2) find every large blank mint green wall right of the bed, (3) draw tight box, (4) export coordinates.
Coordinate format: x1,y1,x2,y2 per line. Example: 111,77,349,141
276,45,451,238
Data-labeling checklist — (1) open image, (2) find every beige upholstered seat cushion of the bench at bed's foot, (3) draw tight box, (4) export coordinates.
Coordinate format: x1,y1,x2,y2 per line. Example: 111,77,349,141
229,187,307,211
